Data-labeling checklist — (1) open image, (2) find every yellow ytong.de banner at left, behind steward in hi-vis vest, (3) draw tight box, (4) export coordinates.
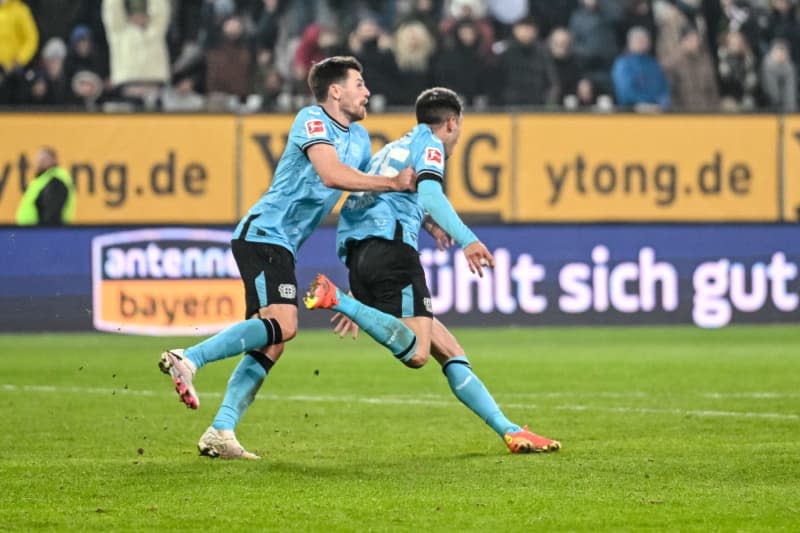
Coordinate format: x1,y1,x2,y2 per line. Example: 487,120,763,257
0,114,236,224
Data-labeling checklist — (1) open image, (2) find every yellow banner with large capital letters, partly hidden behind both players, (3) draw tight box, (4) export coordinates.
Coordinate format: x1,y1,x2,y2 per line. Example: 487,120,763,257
240,113,512,217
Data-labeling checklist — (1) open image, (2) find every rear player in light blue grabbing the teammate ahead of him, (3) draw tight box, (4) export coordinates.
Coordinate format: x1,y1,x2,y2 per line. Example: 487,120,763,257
159,56,414,459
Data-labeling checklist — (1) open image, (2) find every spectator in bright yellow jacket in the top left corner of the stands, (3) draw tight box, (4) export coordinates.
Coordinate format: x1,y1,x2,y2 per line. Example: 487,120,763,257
0,0,39,72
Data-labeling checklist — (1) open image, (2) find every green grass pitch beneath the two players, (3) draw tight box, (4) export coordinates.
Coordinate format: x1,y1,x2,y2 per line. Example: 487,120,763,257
0,326,800,532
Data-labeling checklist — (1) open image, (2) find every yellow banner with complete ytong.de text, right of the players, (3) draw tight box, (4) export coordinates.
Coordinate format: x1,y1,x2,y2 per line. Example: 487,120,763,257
514,115,778,222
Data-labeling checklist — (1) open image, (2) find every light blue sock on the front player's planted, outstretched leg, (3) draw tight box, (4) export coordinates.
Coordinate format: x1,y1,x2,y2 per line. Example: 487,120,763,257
442,355,522,437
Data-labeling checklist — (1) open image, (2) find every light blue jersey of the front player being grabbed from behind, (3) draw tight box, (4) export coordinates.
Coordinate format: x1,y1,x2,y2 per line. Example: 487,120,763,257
336,124,445,262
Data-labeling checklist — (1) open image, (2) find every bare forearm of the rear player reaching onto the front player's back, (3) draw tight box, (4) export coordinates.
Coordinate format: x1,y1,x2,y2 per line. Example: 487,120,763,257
306,143,416,192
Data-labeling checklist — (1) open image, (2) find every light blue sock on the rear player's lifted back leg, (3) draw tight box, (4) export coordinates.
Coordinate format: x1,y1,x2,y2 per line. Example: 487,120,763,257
184,318,281,368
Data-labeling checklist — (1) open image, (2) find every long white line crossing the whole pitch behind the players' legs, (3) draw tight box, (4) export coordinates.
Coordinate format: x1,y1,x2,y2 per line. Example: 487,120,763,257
0,384,800,420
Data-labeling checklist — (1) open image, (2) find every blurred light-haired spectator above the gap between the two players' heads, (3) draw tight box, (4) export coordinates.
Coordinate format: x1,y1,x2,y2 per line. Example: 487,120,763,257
390,21,436,105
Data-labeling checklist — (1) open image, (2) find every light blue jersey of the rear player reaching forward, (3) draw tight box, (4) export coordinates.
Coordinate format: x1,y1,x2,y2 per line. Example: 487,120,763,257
234,105,371,257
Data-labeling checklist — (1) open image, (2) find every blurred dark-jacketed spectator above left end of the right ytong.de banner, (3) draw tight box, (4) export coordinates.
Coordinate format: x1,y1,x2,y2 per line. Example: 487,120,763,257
495,17,558,105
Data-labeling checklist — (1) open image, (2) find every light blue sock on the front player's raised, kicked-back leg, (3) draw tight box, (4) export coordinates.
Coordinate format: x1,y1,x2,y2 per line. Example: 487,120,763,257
333,289,417,363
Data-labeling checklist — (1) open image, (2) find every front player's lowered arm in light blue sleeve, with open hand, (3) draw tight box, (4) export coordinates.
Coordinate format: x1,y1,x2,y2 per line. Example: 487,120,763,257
417,180,494,277
